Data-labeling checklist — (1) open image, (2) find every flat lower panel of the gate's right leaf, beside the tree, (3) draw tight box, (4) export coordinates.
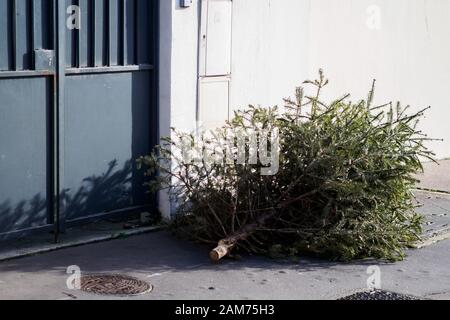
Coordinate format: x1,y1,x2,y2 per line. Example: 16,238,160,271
63,72,150,221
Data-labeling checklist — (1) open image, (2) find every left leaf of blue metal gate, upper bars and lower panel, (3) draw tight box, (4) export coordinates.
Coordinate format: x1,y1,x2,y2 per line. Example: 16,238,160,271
0,0,53,238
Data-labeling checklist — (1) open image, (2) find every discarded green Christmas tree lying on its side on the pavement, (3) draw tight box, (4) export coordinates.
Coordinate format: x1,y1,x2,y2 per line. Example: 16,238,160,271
139,72,433,261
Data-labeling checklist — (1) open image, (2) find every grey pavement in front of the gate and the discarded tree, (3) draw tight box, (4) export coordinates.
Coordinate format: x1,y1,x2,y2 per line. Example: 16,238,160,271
0,232,450,300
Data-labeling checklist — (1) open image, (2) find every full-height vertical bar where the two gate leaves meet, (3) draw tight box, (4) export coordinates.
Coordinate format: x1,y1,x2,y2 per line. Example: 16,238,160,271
52,0,66,241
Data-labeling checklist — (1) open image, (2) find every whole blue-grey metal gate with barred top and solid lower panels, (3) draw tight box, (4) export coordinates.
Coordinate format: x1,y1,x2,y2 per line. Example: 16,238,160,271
0,0,158,238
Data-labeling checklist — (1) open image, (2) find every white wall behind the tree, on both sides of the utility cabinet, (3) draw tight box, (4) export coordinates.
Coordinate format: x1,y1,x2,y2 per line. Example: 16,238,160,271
159,0,450,216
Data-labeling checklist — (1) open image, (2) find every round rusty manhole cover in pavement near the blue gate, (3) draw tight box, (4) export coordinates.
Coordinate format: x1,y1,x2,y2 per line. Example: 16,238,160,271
81,275,153,296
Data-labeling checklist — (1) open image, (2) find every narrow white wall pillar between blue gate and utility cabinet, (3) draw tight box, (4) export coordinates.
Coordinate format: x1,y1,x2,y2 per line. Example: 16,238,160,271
159,0,199,218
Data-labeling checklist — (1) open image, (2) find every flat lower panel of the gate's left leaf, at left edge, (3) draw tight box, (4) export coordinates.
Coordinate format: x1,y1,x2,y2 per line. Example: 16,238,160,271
0,78,51,234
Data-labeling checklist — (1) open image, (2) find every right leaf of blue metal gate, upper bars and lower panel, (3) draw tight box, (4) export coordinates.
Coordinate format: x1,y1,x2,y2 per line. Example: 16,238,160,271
60,0,156,223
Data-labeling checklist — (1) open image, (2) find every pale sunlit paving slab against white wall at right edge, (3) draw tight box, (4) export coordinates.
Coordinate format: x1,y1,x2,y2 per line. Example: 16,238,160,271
417,160,450,193
